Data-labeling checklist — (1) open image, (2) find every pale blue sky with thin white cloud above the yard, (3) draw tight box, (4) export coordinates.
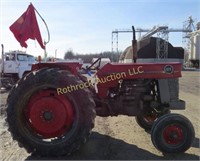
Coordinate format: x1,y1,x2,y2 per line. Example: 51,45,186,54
0,0,200,58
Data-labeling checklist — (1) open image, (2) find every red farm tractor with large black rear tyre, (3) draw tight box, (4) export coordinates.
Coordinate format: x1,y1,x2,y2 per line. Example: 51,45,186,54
7,27,195,156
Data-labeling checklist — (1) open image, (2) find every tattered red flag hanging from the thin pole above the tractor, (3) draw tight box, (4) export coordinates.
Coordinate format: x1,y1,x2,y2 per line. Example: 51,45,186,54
10,4,45,49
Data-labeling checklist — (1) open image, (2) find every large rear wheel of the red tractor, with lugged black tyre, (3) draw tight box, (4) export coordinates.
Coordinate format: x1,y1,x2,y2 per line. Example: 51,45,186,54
7,68,95,156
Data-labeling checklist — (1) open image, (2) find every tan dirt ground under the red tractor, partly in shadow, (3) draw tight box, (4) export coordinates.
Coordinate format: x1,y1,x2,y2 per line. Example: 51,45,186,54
0,71,200,161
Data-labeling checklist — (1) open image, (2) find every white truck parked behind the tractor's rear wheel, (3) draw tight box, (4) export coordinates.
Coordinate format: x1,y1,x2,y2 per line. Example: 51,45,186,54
0,45,36,88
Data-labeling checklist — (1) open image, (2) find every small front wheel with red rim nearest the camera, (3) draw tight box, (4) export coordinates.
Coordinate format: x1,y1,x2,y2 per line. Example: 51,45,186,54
151,114,195,153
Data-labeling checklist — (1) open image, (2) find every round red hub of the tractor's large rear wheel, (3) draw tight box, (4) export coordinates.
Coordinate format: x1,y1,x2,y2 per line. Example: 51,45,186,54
25,90,74,138
